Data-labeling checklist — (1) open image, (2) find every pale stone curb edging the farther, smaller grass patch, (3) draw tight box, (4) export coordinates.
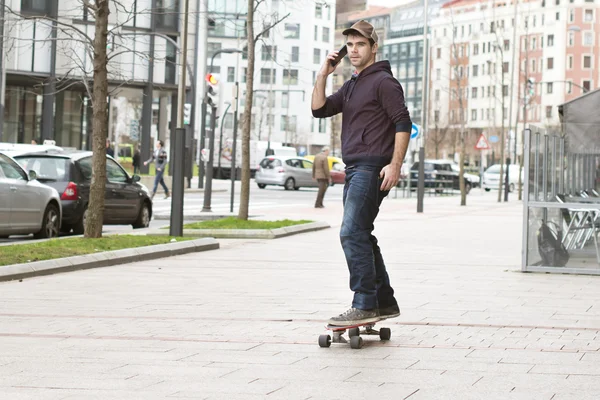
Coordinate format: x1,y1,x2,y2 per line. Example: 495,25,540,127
147,222,330,239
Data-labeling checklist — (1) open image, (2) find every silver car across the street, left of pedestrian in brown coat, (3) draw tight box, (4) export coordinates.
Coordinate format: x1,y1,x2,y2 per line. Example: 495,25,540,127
254,156,318,190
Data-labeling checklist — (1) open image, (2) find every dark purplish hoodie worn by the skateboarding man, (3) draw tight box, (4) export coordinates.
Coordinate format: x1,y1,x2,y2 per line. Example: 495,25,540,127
313,61,412,167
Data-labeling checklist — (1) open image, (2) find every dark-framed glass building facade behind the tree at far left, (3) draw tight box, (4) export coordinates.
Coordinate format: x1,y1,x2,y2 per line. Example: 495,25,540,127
0,0,196,166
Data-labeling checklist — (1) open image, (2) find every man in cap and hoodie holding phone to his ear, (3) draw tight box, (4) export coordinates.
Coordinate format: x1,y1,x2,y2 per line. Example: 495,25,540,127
312,21,412,326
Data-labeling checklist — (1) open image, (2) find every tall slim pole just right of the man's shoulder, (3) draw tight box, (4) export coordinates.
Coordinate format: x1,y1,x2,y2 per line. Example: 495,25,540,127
418,0,429,213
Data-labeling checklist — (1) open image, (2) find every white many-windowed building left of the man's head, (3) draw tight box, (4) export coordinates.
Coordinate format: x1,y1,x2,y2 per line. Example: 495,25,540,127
208,0,335,154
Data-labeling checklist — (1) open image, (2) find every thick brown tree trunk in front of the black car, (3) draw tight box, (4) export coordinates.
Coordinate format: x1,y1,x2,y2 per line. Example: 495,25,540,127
84,0,109,238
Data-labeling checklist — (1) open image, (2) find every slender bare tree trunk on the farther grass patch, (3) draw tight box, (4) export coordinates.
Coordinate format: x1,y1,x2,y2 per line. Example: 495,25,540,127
238,0,255,220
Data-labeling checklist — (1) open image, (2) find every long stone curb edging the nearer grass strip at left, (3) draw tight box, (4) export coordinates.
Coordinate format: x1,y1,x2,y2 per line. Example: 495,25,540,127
0,238,219,282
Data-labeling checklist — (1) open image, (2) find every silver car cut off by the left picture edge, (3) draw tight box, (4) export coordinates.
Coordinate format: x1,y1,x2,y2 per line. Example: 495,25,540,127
0,153,62,239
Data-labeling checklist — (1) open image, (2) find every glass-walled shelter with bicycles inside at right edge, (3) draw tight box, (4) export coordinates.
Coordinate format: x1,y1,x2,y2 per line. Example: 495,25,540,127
522,91,600,275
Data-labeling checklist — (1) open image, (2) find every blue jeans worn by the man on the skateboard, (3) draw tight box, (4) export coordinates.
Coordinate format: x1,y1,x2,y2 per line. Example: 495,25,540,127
340,166,398,310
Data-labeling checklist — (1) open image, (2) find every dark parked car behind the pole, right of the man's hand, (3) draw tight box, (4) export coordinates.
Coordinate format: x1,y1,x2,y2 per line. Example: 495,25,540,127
410,160,473,194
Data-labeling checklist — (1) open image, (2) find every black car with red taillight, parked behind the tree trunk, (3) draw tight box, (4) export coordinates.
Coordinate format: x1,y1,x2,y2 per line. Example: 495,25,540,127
14,151,152,235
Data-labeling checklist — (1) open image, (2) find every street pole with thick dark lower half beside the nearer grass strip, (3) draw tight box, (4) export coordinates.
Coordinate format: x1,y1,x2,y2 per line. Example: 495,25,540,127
169,0,190,236
